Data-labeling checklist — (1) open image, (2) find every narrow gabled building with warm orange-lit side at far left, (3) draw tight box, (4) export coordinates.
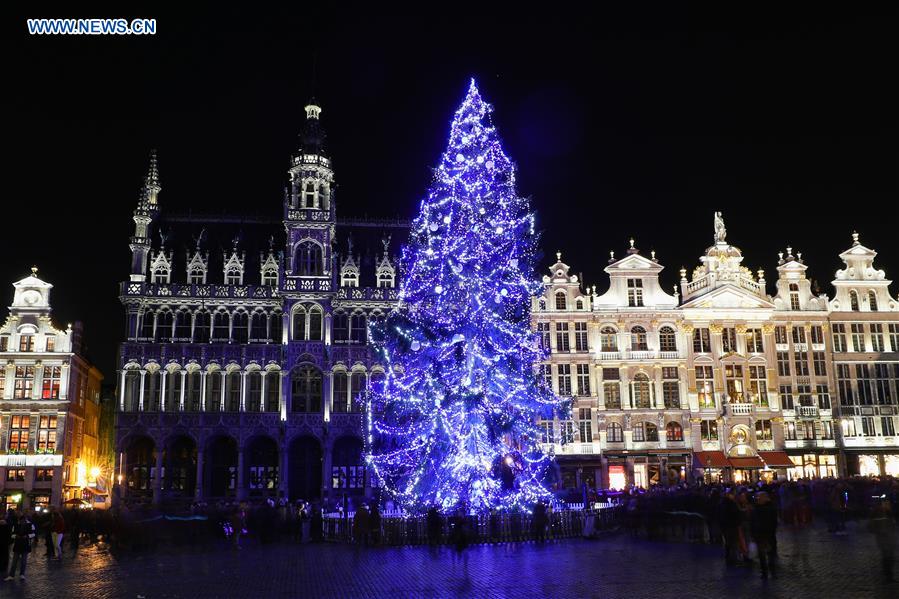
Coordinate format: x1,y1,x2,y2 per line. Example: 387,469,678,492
0,268,103,507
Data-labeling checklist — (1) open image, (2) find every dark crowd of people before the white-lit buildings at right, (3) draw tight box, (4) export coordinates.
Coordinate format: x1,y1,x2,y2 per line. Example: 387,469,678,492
618,477,899,579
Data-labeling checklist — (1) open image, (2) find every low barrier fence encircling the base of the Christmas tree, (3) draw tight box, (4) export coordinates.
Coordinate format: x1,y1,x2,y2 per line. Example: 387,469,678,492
322,504,623,545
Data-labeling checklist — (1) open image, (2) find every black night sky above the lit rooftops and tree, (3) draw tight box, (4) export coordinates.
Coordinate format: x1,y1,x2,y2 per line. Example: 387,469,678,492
0,3,899,376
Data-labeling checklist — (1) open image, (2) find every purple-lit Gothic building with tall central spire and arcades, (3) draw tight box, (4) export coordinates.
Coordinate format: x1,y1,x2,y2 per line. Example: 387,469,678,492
116,102,407,503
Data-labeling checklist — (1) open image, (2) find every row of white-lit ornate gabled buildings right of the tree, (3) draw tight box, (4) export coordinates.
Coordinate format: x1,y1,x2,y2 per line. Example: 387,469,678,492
533,214,899,488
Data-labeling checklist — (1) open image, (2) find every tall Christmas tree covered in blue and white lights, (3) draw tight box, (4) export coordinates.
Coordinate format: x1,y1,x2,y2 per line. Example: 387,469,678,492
367,80,561,513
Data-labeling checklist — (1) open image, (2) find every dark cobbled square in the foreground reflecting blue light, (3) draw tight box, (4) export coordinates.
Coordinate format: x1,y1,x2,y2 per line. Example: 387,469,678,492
0,525,899,599
